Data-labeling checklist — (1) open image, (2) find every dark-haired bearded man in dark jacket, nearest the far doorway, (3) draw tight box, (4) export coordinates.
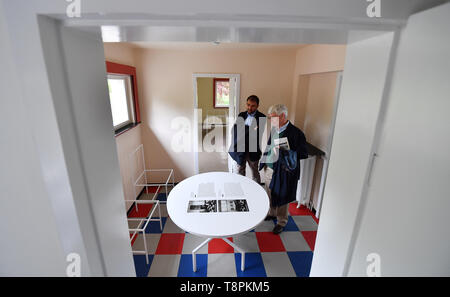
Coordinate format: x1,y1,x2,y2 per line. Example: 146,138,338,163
229,95,266,183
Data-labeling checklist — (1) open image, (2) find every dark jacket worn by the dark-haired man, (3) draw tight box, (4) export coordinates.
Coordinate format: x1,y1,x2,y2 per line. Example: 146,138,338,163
228,110,266,165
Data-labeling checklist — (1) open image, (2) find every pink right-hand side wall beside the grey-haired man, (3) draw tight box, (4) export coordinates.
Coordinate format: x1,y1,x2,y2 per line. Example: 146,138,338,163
290,44,346,209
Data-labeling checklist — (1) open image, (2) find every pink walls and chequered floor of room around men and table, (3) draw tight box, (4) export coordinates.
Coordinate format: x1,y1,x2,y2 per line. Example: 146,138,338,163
104,42,346,277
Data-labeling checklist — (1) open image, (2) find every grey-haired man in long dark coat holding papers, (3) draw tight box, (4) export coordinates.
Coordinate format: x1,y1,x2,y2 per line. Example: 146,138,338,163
260,104,308,234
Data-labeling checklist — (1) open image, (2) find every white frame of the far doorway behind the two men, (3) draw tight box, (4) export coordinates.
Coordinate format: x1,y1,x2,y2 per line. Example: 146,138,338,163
192,73,241,174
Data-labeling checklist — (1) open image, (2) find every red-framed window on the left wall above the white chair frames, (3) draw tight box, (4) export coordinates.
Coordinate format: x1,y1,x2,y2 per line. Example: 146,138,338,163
106,62,140,136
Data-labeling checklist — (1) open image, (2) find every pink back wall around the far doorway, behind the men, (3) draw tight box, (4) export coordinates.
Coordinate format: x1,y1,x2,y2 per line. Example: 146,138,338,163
136,48,296,181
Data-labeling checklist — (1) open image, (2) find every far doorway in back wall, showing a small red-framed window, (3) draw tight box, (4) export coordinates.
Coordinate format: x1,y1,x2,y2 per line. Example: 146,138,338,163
193,73,240,174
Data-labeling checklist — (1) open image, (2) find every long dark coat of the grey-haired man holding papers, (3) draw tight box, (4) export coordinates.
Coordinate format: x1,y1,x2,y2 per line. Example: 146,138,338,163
260,123,308,207
